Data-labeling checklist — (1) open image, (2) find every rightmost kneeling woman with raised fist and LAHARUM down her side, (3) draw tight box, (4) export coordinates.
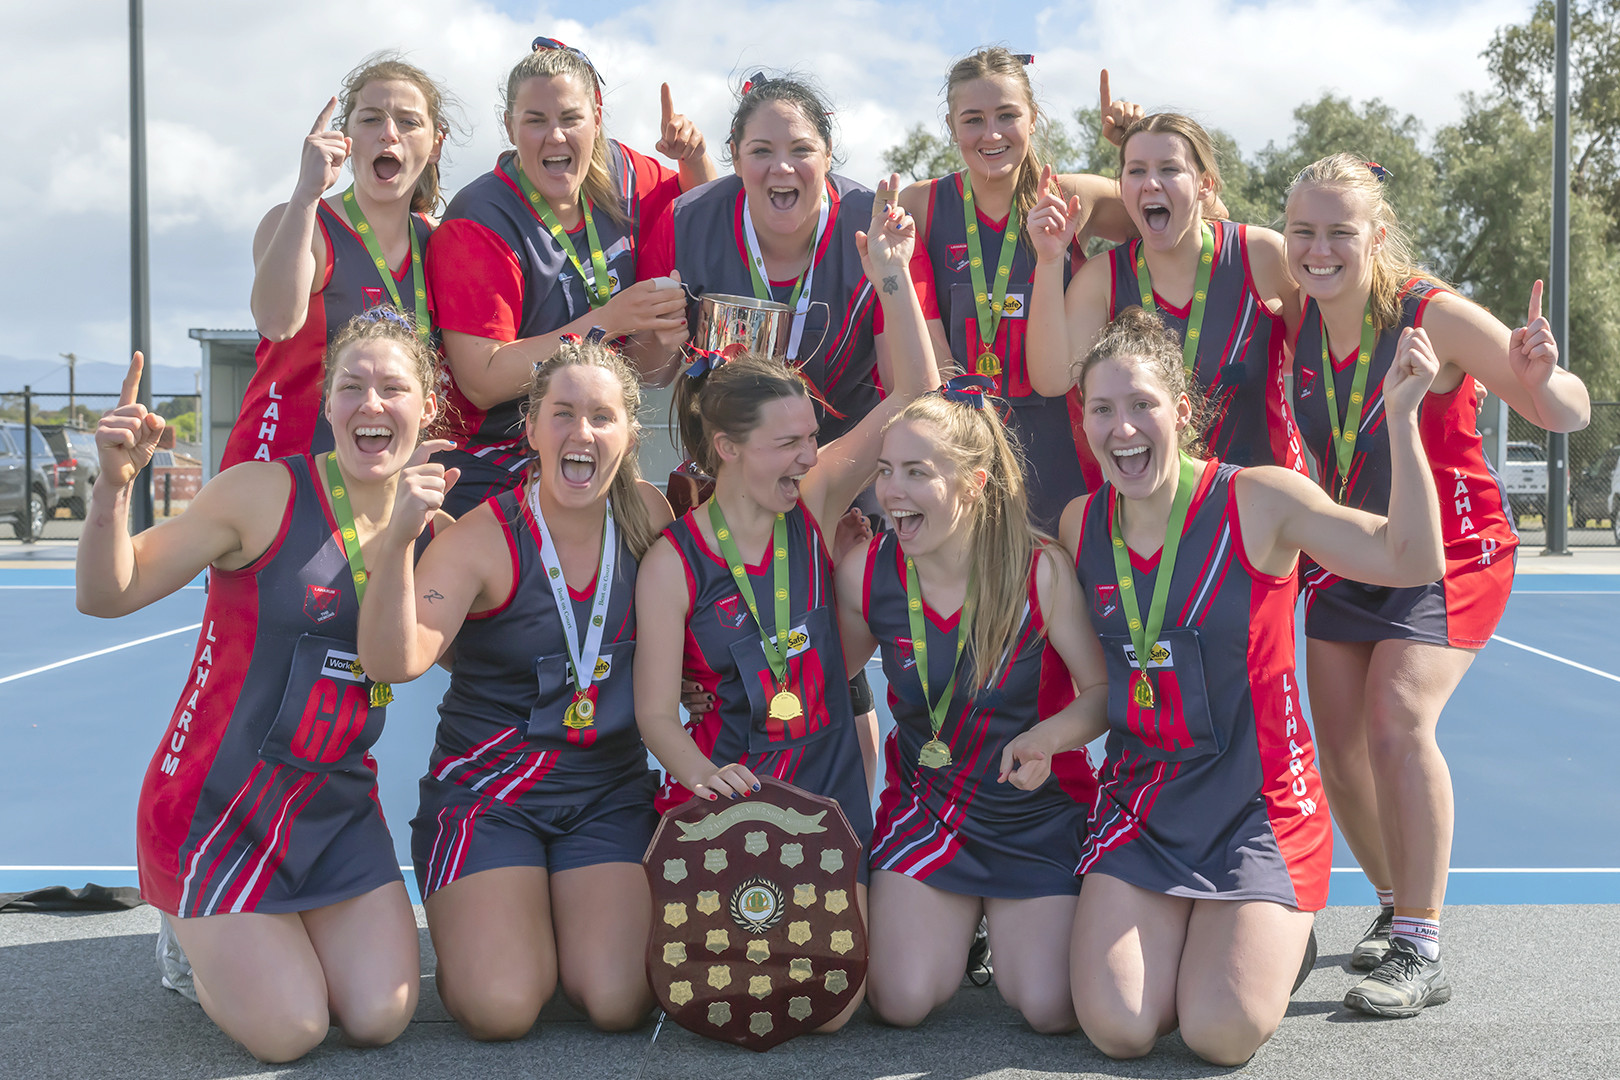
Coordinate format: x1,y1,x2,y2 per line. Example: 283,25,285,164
1063,311,1443,1065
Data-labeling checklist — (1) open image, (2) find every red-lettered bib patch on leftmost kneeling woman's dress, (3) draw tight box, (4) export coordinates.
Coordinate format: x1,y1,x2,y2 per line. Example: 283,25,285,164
259,633,386,772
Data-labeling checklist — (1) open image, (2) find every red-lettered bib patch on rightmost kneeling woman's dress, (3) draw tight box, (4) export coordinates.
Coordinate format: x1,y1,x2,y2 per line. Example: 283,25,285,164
1102,628,1225,761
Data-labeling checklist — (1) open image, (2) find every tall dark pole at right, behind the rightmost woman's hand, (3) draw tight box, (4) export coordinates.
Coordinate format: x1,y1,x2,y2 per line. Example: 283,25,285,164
1542,0,1570,555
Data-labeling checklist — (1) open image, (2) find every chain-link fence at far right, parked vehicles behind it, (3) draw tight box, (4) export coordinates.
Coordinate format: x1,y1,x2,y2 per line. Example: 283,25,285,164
1481,400,1620,549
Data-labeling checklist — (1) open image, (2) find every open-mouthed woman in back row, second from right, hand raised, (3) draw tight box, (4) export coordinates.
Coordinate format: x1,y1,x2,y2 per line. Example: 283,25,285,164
1029,113,1304,471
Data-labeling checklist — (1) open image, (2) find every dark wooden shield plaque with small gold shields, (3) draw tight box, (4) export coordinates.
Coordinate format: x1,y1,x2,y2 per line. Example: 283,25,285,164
642,777,867,1051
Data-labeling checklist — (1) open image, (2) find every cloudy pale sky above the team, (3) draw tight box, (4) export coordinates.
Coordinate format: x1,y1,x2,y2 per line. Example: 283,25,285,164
0,0,1531,383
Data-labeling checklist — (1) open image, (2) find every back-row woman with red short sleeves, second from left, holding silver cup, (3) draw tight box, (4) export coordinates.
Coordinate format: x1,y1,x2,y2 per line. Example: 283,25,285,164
428,37,714,515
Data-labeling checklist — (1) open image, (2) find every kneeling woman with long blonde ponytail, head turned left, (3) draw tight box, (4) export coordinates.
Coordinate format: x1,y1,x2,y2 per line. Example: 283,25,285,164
838,376,1108,1031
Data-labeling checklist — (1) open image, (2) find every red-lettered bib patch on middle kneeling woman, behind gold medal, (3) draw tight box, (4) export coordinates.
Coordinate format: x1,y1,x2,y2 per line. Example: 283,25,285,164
731,607,852,753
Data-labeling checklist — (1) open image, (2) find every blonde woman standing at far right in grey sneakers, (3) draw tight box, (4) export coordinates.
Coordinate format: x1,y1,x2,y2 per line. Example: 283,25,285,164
1288,154,1591,1017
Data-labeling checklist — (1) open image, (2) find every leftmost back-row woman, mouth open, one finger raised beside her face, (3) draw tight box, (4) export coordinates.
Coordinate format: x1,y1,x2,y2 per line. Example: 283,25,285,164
220,53,450,470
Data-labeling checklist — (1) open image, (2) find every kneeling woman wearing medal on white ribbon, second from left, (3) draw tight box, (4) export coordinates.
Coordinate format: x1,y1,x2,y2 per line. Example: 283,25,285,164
360,338,669,1040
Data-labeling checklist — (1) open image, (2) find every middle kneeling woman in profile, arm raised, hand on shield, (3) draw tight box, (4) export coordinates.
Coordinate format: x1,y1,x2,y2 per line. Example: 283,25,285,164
635,196,940,1027
